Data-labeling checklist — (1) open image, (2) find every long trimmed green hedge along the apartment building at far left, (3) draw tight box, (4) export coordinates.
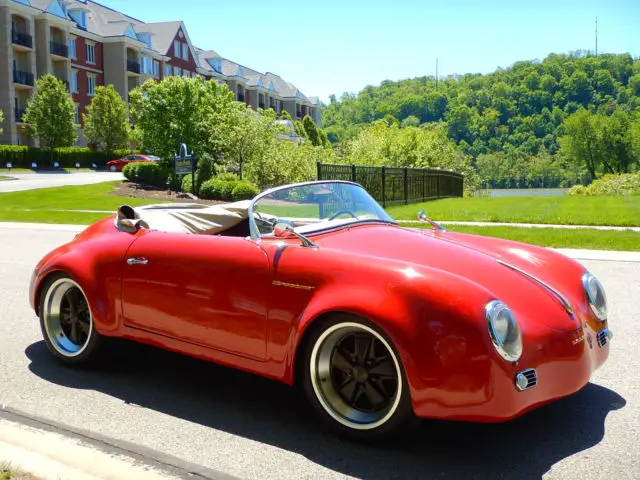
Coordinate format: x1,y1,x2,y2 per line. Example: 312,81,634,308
0,145,139,170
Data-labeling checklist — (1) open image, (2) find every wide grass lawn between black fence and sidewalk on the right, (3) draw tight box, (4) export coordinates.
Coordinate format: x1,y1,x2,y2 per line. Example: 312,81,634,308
387,196,640,226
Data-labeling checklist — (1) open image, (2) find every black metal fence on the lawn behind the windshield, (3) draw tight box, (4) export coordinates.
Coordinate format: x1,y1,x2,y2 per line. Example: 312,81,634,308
317,163,464,207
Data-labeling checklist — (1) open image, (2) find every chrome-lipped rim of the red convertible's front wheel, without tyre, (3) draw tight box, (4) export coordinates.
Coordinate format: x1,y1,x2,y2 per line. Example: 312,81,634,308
310,322,402,430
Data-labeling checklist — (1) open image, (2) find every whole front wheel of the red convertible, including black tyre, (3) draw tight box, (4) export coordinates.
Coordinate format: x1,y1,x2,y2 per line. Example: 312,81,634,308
302,315,417,440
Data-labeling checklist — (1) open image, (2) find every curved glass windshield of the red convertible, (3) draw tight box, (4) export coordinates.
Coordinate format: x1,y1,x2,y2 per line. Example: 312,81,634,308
253,182,395,236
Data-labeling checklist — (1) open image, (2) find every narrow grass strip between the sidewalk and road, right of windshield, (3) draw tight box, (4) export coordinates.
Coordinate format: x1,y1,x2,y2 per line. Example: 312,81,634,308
410,224,640,252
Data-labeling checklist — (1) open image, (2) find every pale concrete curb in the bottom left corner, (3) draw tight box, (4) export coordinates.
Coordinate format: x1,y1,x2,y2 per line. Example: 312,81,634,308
0,405,238,480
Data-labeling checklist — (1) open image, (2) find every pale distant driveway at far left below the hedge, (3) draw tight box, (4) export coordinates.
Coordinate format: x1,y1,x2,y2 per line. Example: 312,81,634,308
0,172,124,193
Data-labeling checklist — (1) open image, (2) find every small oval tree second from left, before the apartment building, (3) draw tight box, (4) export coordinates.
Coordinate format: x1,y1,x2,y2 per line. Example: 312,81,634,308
83,85,131,154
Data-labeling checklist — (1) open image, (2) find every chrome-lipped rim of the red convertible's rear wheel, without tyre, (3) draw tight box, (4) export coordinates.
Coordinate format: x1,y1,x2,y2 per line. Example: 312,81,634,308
43,278,93,357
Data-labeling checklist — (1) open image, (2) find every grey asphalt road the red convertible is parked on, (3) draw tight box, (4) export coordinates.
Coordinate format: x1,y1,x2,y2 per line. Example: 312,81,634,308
0,228,640,480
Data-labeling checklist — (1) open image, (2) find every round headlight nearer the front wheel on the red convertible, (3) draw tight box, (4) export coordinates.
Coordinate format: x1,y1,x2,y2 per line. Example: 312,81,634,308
484,300,522,362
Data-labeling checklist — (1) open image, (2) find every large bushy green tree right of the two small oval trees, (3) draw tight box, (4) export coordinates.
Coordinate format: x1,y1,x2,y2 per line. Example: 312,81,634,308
129,77,241,159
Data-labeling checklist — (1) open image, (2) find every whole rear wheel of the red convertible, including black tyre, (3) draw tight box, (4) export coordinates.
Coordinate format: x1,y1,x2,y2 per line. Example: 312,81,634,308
40,275,102,366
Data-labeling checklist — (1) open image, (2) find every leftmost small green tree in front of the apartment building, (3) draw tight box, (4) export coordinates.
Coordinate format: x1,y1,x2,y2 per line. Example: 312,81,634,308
22,73,78,159
